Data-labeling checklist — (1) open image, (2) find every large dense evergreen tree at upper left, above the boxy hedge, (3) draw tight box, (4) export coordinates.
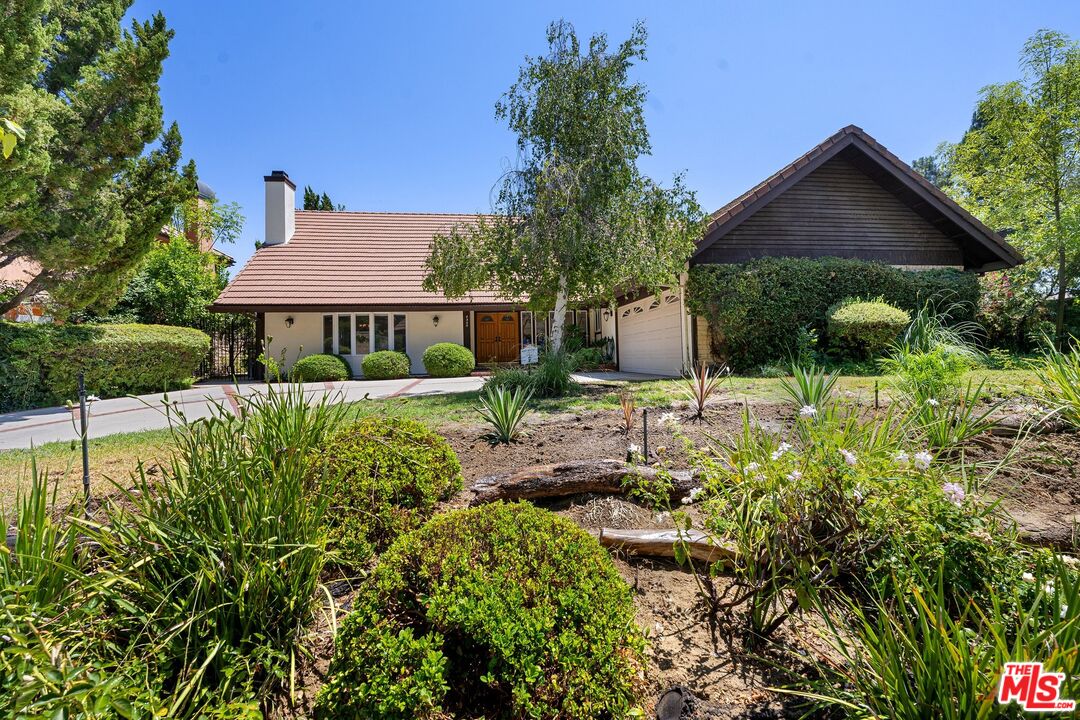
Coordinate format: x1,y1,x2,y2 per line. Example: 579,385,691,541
0,0,188,313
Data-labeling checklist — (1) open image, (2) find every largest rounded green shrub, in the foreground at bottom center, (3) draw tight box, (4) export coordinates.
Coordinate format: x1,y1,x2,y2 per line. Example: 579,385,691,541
315,503,643,720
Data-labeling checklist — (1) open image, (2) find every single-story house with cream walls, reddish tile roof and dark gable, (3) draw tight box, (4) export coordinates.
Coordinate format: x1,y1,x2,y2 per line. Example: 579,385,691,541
214,125,1023,376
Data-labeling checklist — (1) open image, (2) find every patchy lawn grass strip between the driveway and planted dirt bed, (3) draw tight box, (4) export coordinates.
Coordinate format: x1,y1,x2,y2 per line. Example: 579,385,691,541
0,369,1038,508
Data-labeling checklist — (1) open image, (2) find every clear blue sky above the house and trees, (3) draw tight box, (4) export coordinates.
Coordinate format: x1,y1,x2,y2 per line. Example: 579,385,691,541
131,0,1080,268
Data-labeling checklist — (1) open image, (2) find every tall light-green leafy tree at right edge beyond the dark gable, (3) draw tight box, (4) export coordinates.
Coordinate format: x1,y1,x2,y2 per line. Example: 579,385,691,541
949,30,1080,342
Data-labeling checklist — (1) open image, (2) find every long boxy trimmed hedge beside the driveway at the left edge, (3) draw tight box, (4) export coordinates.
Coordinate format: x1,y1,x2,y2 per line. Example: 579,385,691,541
0,322,210,411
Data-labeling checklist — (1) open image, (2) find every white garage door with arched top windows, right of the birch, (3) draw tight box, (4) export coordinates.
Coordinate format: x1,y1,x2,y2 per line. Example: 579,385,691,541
618,294,683,376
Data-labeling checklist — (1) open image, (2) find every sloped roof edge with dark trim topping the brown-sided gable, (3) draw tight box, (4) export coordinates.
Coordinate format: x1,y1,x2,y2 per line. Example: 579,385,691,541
698,125,1024,267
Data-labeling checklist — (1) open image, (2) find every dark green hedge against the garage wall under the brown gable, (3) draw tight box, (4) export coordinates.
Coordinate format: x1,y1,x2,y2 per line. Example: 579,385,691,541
687,258,980,370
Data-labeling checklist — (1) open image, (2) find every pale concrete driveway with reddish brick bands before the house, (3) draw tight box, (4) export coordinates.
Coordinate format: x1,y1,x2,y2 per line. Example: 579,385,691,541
0,377,484,450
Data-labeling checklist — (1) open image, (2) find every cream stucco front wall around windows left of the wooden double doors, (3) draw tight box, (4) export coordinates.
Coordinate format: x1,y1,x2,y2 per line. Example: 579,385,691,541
266,310,464,377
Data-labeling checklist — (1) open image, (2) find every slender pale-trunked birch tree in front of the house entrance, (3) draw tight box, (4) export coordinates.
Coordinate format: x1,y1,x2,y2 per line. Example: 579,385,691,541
424,22,703,351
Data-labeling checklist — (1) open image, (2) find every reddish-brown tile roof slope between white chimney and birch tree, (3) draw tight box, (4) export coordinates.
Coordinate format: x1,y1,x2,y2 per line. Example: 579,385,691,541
214,210,505,311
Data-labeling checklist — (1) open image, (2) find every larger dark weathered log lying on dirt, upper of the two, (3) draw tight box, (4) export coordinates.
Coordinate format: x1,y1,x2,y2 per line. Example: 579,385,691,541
472,460,698,505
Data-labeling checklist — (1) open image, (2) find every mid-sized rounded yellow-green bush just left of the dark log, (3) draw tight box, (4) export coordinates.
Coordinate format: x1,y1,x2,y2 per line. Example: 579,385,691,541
320,417,461,566
